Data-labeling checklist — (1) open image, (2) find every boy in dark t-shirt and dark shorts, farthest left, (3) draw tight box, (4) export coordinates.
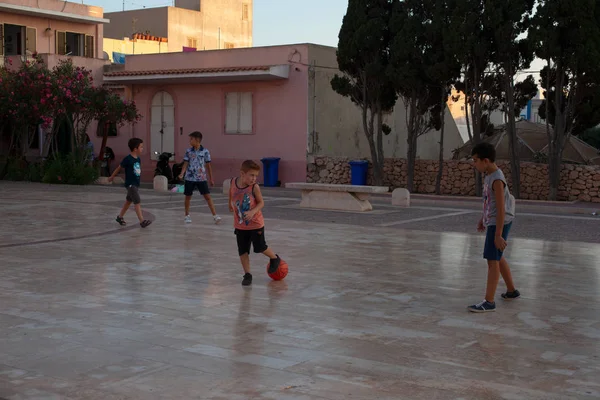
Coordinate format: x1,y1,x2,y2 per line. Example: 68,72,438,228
108,138,152,228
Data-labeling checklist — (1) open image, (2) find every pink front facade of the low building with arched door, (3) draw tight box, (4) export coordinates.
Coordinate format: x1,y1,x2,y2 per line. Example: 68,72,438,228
98,45,308,182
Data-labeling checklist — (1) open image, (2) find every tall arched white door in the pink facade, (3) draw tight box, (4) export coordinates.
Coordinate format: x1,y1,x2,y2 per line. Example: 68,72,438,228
150,91,175,160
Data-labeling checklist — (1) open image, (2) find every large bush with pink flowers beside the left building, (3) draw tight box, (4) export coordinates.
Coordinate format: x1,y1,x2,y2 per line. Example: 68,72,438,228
0,54,140,181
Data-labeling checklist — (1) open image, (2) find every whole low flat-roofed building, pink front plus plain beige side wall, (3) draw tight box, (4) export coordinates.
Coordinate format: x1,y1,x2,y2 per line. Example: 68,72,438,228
102,44,462,184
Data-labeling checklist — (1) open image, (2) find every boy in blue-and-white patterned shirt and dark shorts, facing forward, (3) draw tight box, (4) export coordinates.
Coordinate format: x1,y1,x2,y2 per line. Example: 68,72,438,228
179,131,221,224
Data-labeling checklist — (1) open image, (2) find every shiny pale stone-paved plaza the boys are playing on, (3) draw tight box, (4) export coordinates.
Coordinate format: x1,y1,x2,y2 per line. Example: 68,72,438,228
0,182,600,400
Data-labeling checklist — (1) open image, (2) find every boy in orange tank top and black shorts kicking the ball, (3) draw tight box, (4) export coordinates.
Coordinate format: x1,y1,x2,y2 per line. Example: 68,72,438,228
229,160,281,286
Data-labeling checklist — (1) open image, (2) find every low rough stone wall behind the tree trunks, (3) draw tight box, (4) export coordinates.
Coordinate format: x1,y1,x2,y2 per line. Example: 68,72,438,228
306,156,600,203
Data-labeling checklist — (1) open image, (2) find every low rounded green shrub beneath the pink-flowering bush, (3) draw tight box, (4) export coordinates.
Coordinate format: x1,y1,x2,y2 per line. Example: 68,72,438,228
42,151,99,185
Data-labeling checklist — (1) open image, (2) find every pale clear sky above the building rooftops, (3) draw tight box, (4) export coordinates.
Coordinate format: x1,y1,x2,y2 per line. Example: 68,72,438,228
94,0,348,47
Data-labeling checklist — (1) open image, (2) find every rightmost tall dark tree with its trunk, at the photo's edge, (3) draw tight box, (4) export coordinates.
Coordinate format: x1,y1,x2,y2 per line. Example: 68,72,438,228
529,0,600,200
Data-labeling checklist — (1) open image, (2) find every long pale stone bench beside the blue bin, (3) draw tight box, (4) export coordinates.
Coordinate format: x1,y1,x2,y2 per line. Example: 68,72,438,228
285,182,390,211
